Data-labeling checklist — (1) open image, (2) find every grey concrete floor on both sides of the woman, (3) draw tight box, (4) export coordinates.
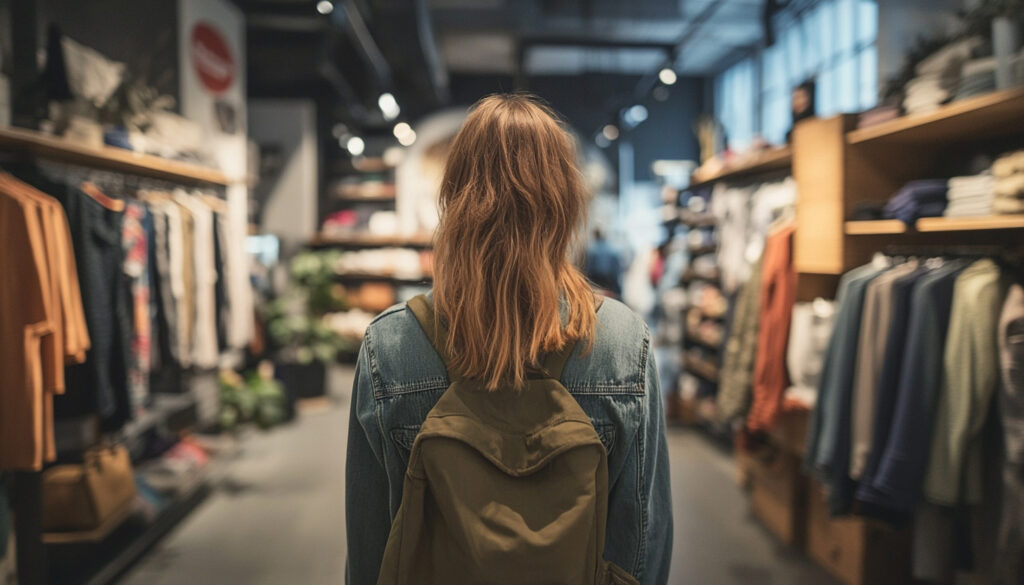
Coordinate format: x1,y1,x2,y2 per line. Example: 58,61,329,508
121,370,837,585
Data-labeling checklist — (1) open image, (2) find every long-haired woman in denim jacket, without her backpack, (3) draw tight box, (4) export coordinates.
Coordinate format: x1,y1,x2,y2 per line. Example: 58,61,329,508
345,95,672,585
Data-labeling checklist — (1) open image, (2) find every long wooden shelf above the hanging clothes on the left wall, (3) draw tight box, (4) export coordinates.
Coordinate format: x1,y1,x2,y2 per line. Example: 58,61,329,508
0,128,228,184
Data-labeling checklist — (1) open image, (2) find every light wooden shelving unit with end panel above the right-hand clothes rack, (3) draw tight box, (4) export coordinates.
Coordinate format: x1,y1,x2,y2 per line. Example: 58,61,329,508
793,88,1024,275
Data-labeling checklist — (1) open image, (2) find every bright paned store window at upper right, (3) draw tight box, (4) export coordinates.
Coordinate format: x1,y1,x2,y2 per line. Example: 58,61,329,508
715,0,879,151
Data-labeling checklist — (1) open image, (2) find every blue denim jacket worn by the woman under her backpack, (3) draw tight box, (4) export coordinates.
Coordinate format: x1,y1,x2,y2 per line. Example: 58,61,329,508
345,299,672,585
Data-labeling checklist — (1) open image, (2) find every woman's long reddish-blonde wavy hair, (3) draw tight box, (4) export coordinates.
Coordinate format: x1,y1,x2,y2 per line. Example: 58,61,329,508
434,94,597,389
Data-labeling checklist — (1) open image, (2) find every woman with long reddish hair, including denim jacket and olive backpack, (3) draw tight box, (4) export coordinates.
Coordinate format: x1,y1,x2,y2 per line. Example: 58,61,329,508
346,95,672,585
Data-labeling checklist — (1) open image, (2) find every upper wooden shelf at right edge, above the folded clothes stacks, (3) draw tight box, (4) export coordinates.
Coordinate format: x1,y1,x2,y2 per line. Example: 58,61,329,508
846,88,1024,144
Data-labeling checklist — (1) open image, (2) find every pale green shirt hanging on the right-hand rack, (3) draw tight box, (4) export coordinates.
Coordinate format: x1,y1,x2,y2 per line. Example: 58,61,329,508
925,258,1009,506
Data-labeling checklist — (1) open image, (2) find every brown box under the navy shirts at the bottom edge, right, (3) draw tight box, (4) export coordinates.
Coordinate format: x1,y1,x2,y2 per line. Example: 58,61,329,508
806,482,912,585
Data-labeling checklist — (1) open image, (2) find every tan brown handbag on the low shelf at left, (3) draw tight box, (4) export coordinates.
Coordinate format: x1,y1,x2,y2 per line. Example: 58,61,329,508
42,445,135,532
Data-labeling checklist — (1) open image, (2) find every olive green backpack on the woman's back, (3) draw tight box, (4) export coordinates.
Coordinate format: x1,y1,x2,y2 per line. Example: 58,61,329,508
377,295,637,585
